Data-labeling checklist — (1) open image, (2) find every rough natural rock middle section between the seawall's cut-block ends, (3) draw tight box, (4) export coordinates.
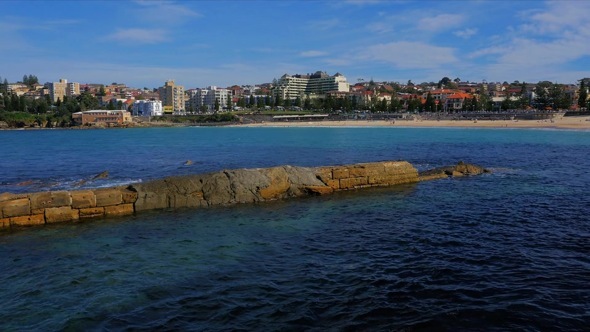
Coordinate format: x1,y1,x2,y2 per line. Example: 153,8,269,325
128,164,364,211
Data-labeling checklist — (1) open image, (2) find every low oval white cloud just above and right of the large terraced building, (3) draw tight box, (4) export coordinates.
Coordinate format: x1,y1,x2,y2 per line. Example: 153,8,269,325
361,41,457,69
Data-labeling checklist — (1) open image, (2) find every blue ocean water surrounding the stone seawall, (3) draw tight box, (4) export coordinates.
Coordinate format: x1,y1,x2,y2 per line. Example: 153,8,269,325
0,127,590,331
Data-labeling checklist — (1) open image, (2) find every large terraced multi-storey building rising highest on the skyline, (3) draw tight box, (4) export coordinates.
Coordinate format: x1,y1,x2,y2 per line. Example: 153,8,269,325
274,71,350,99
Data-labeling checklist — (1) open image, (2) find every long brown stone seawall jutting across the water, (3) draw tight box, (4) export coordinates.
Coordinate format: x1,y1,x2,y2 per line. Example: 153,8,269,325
0,161,485,230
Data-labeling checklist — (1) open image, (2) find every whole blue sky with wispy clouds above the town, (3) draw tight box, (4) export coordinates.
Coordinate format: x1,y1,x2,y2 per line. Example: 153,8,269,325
0,0,590,89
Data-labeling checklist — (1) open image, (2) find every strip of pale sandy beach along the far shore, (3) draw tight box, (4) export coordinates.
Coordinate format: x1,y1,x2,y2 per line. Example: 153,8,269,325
240,116,590,130
